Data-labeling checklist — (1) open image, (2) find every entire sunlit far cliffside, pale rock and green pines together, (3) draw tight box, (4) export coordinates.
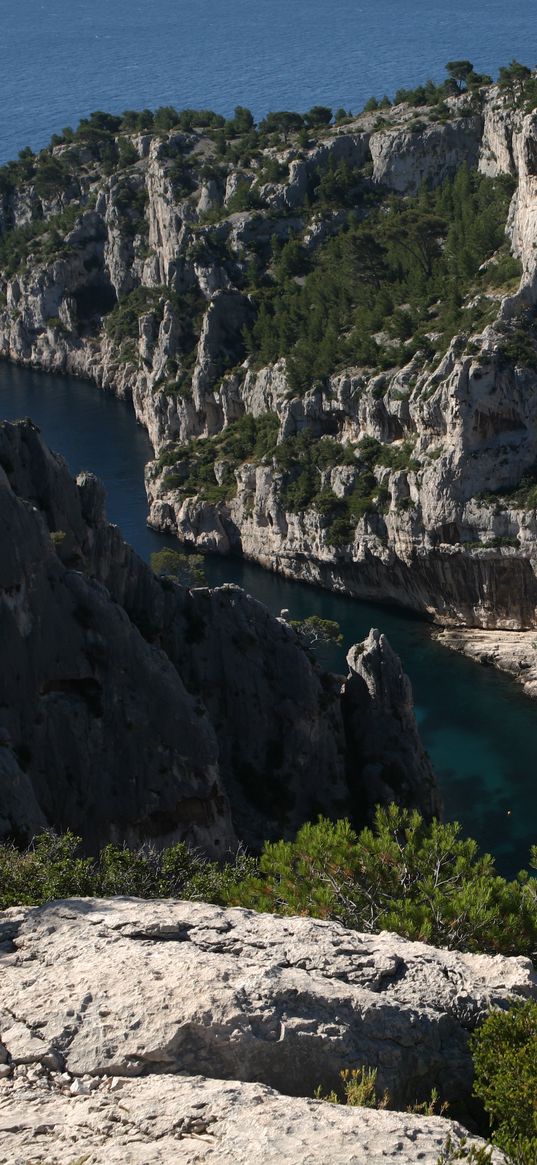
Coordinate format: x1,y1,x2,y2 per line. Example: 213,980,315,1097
0,79,537,643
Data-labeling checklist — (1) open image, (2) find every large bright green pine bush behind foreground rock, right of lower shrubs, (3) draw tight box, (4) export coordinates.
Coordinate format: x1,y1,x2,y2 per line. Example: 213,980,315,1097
233,806,537,954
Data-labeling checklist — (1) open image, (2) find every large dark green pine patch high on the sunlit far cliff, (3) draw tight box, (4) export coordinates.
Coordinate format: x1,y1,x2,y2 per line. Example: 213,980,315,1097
245,163,513,394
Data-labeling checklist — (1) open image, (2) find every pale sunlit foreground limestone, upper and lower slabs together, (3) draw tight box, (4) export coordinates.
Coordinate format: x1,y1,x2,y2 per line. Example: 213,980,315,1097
0,899,526,1165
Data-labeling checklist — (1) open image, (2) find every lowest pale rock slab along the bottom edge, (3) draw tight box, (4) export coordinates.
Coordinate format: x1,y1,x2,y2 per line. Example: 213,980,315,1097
0,1075,503,1165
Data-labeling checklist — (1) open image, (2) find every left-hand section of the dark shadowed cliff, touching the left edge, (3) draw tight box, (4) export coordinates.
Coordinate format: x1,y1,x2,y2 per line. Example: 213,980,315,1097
0,424,231,852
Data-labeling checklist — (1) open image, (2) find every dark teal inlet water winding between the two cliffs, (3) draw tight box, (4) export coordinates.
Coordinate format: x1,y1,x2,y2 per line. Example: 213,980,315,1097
0,363,537,875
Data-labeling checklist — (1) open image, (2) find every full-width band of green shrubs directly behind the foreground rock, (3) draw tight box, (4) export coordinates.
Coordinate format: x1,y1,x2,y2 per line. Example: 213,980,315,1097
0,805,537,955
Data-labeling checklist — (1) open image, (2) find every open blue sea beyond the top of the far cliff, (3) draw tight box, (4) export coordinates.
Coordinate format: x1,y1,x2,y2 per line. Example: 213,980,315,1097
0,0,537,161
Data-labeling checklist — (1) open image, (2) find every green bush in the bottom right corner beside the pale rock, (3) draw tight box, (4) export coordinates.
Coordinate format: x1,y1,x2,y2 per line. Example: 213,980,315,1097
472,1002,537,1165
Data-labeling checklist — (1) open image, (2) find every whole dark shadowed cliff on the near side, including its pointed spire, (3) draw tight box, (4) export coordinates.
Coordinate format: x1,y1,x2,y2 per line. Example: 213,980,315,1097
0,422,438,854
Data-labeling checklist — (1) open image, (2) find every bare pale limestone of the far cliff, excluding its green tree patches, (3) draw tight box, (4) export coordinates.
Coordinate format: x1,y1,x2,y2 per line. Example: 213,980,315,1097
0,86,537,629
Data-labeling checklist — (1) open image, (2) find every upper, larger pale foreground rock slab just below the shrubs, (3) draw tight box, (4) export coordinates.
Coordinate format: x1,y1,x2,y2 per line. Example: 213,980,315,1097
0,898,537,1115
